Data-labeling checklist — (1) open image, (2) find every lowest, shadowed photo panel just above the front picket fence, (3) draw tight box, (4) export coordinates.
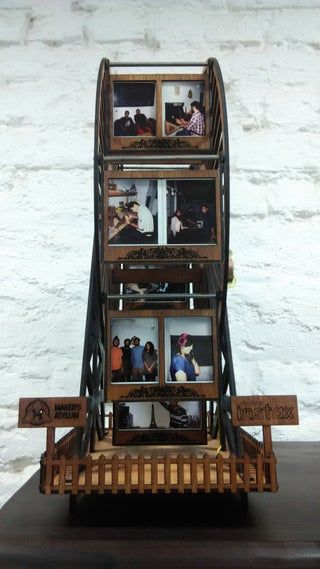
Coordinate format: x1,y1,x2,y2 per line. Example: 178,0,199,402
113,400,207,445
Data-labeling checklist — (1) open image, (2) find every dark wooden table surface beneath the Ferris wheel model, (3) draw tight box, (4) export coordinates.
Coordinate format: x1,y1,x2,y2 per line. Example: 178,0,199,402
0,442,320,569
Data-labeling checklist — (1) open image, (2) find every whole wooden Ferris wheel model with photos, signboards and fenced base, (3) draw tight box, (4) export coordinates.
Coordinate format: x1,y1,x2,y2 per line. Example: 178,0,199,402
19,58,298,508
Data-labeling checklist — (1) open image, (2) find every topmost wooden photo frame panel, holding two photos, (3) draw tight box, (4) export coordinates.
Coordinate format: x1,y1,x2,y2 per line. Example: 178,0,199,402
108,73,210,154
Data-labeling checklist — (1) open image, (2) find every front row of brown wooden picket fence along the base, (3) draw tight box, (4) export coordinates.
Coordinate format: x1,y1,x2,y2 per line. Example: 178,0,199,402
40,448,278,494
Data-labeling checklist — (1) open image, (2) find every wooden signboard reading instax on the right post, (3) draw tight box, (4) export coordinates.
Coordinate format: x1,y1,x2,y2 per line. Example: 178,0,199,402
231,395,299,427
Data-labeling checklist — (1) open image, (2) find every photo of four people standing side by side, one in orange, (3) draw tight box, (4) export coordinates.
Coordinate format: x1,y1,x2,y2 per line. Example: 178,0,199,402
110,318,158,383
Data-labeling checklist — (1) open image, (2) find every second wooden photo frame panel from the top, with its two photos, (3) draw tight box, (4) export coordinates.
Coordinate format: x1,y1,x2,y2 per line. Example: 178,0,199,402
103,170,221,263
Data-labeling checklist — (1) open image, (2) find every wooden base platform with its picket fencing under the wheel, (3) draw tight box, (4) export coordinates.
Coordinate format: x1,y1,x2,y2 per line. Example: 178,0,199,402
40,431,278,496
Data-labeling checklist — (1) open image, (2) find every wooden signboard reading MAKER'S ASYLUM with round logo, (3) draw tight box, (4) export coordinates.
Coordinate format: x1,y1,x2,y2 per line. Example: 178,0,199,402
18,397,87,428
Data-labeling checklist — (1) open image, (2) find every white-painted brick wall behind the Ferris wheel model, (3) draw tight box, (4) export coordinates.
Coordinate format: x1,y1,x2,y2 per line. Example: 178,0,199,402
0,0,320,503
